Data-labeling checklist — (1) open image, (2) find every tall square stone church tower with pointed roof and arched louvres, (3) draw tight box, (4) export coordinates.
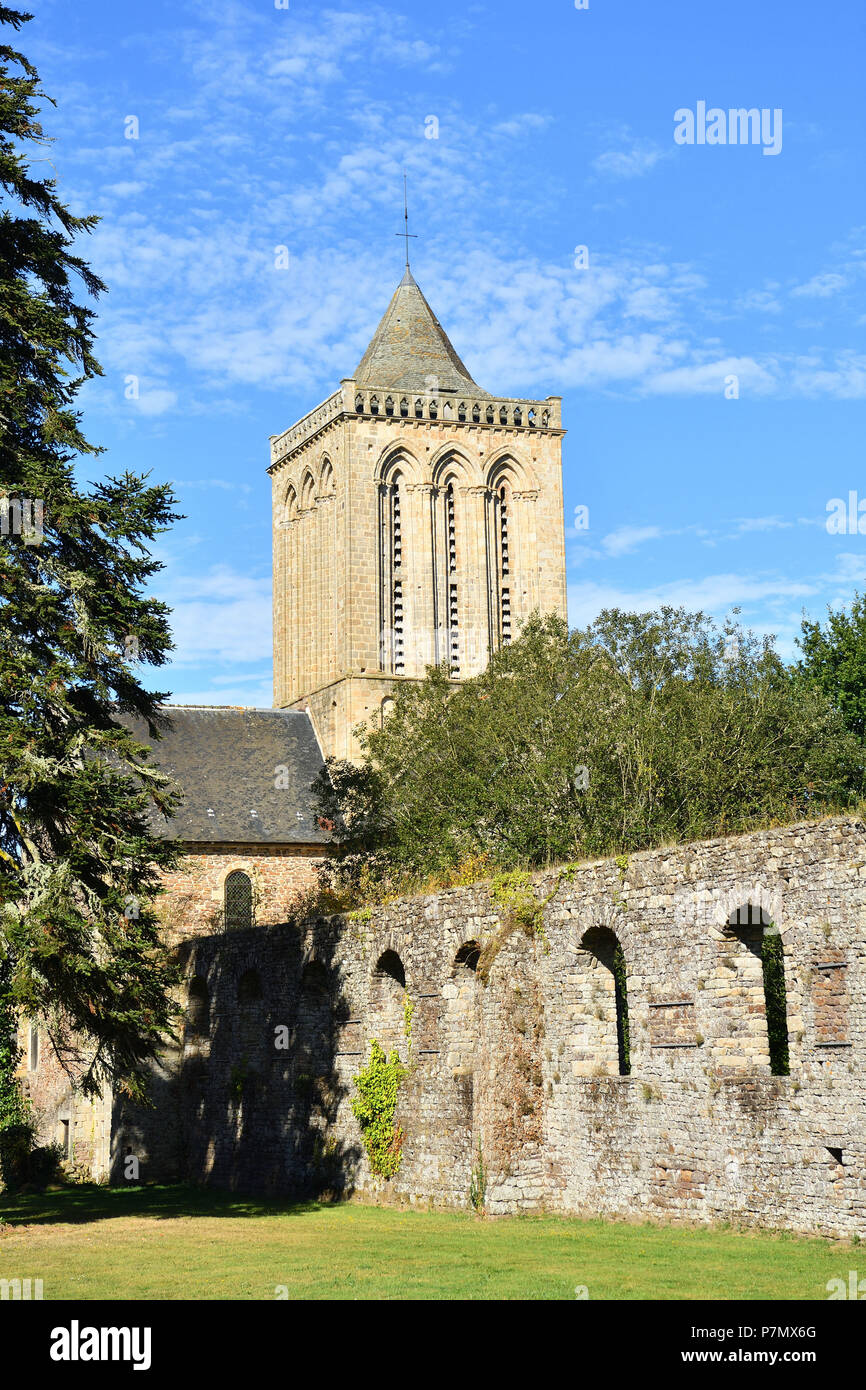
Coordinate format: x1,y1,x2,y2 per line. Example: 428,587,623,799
268,267,566,758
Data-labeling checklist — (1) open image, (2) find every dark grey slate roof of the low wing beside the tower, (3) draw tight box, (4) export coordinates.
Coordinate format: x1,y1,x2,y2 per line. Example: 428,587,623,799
125,705,329,845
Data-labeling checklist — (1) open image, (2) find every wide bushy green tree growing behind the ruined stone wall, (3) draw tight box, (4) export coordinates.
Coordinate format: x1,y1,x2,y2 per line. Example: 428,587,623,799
318,609,856,888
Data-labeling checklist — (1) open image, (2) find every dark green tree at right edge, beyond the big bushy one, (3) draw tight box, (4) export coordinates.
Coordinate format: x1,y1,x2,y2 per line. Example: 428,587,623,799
796,594,866,787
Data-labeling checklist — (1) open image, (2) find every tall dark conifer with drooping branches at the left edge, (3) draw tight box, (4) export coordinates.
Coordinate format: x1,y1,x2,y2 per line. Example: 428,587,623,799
0,6,183,1095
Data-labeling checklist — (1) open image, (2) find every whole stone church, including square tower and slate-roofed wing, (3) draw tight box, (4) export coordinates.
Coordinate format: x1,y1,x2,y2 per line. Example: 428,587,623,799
22,265,566,1176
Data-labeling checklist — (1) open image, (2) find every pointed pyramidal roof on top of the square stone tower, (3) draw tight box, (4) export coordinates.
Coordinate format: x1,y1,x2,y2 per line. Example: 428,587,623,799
353,268,489,399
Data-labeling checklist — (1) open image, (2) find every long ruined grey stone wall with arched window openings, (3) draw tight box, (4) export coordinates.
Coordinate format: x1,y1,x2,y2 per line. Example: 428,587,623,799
48,819,866,1236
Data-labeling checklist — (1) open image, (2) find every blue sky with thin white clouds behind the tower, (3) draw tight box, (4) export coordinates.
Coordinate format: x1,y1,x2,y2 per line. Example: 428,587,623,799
19,0,866,705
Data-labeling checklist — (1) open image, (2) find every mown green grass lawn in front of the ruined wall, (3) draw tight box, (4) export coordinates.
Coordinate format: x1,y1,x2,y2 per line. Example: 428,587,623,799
0,1186,856,1300
